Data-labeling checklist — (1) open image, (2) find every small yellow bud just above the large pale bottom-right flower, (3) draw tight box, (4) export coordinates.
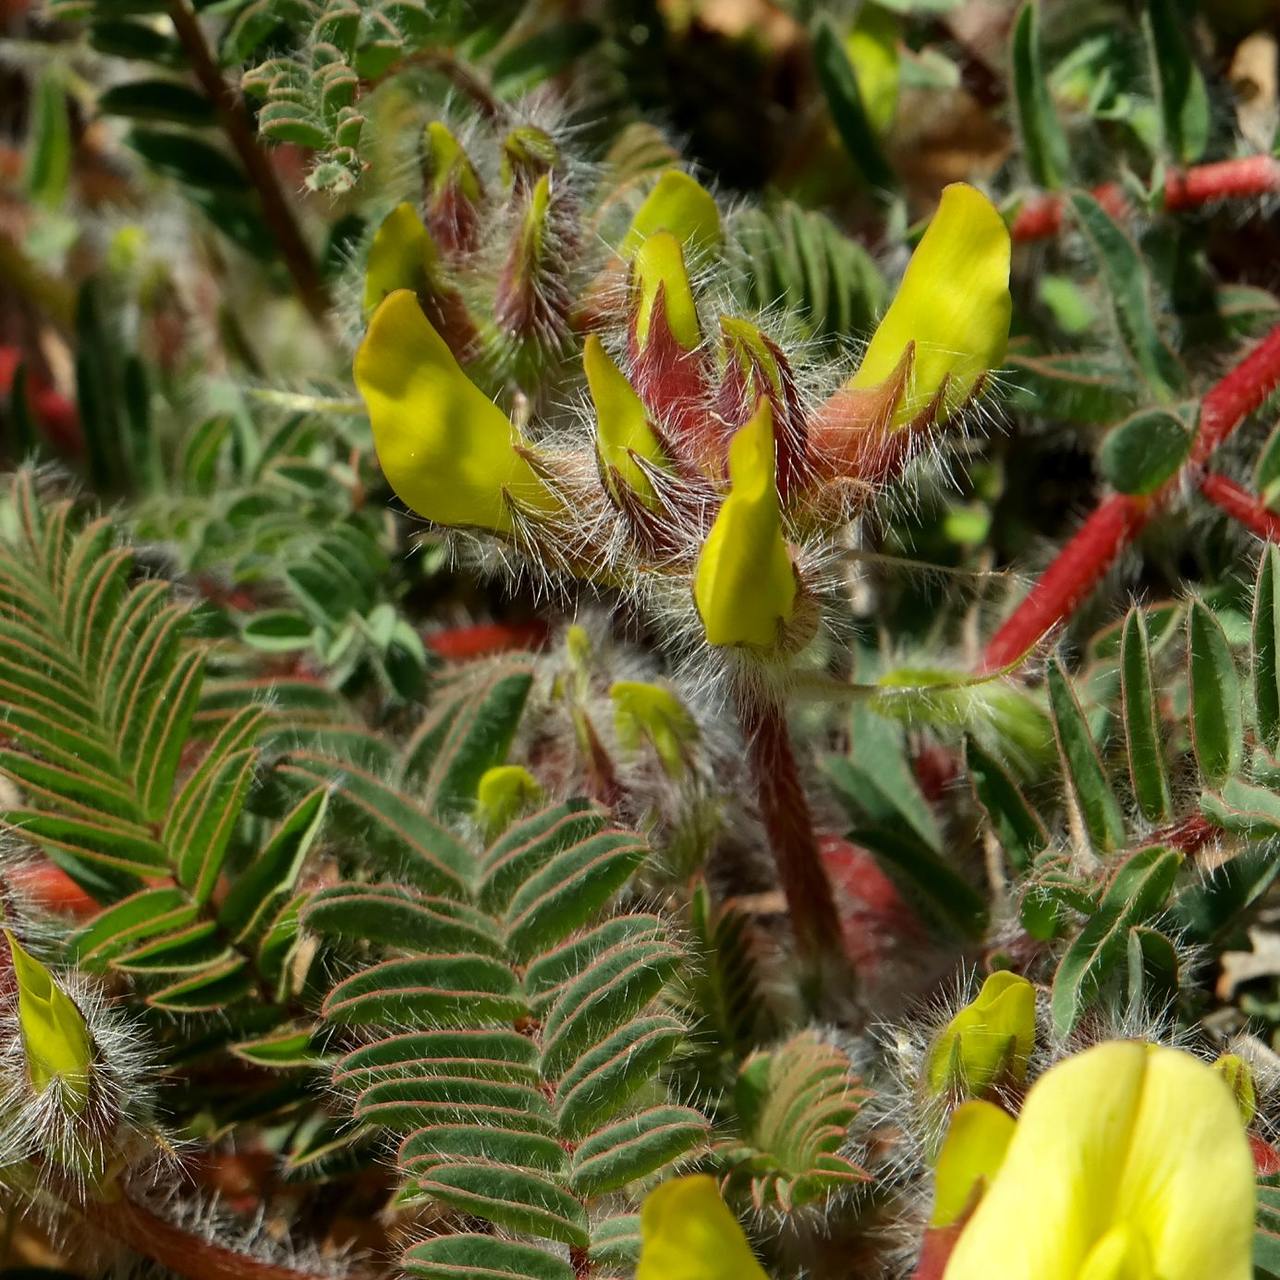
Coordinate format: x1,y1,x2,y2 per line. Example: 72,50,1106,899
924,970,1036,1094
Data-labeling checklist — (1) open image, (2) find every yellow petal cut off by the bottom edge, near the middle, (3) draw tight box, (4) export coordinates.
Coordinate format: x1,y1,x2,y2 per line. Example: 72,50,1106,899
636,1174,768,1280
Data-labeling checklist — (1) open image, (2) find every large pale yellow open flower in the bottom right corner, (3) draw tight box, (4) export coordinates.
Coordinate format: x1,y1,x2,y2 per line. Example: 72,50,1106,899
945,1041,1254,1280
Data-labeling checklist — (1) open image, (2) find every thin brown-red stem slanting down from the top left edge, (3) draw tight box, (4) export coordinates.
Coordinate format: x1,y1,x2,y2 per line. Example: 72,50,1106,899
169,0,329,328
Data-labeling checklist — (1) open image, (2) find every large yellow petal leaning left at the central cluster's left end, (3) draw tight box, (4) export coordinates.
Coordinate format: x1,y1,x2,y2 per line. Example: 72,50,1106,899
355,289,561,534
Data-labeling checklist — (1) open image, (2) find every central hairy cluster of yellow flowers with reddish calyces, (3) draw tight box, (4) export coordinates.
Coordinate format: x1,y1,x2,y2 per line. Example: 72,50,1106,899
355,138,1010,680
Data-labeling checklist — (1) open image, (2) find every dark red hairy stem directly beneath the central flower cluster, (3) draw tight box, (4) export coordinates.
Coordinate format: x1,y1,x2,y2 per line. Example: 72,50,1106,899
737,690,844,961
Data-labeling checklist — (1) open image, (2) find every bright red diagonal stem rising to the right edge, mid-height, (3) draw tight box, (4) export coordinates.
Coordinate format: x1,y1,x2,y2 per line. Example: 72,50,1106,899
982,325,1280,671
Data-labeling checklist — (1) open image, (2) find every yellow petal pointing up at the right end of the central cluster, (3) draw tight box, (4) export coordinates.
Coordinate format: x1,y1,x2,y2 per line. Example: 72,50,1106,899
847,182,1011,426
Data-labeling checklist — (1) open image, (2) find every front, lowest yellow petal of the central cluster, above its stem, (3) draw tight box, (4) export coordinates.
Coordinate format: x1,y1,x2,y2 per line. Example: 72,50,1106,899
694,399,796,649
